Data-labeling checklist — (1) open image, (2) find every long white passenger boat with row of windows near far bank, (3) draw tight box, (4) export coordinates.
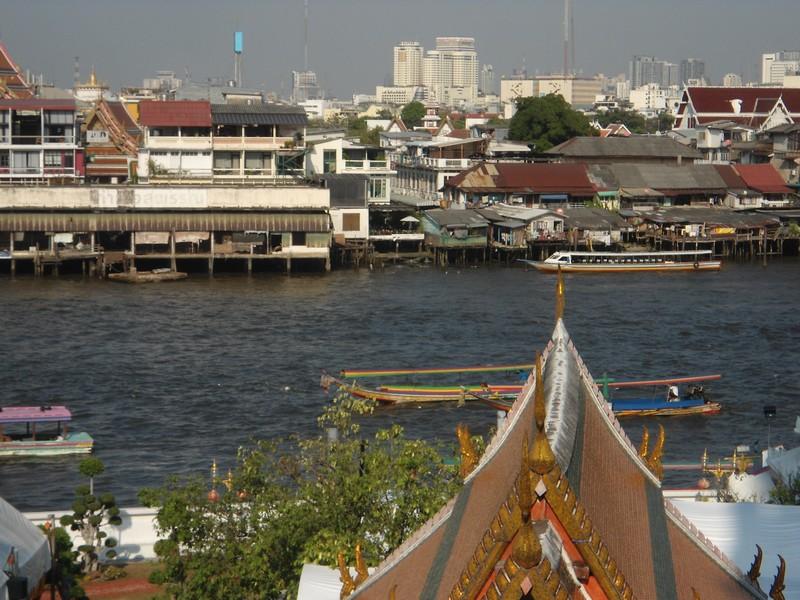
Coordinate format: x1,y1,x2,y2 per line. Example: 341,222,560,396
523,250,722,273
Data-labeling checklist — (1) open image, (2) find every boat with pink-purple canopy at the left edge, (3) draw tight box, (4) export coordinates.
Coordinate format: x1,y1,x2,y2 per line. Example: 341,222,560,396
0,406,94,456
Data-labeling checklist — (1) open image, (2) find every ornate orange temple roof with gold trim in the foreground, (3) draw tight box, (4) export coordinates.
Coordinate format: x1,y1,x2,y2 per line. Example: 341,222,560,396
352,282,765,600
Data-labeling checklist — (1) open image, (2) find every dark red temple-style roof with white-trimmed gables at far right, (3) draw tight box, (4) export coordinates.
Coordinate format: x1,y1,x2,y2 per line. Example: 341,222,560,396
687,87,800,115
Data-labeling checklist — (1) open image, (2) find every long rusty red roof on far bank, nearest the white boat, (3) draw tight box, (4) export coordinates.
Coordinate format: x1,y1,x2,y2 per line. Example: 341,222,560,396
445,163,597,195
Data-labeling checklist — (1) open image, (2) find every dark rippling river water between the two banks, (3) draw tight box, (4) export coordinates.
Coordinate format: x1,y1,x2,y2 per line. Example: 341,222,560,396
0,259,800,510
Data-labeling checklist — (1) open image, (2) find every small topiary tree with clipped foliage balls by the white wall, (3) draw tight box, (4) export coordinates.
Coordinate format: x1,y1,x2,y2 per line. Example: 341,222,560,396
61,457,122,573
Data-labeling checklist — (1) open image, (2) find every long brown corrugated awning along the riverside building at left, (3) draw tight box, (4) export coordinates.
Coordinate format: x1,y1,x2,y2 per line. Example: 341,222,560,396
0,212,331,233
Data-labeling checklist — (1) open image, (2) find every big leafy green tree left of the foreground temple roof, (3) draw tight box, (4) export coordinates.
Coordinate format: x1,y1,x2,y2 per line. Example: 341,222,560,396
140,395,460,598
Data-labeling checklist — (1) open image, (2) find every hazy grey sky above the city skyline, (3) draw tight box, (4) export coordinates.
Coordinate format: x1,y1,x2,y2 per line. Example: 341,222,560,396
0,0,800,98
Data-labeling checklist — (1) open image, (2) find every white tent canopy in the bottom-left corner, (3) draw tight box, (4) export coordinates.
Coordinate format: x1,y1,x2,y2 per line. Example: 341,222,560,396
0,498,50,600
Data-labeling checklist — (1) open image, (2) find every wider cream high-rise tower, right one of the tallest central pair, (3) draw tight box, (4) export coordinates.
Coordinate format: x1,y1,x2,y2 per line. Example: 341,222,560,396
422,37,478,105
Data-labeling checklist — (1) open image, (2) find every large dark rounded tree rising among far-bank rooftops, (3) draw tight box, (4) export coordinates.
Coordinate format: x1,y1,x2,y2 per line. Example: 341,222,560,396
508,94,597,152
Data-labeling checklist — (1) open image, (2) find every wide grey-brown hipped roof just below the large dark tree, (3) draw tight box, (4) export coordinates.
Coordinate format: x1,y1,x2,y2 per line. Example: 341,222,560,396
545,135,700,158
